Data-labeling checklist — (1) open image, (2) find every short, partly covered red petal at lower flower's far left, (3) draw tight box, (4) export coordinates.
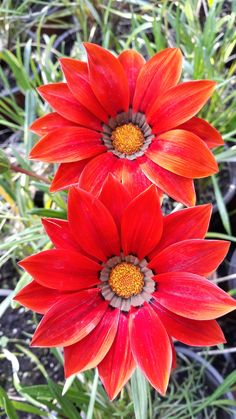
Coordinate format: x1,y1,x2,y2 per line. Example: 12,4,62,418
14,281,64,314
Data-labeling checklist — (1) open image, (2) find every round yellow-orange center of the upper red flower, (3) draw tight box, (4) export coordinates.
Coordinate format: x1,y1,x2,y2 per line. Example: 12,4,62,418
111,123,144,154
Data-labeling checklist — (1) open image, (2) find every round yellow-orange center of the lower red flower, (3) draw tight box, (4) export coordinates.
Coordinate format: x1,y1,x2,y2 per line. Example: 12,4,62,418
109,262,144,298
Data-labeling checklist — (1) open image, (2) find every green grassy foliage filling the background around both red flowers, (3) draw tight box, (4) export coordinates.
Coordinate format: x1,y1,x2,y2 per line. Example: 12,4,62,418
0,0,236,419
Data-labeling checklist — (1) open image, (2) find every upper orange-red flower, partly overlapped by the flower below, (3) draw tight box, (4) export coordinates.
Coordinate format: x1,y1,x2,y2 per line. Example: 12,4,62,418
30,43,223,206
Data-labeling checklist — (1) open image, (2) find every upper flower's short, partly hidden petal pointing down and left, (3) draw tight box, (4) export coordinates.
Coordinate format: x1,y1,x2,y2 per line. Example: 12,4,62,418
50,160,89,192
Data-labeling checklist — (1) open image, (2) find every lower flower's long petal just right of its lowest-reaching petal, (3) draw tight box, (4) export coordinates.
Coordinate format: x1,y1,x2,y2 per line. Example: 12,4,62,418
130,304,172,395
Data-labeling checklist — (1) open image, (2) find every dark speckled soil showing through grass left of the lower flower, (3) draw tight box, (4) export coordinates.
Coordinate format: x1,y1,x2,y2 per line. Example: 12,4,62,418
0,261,64,400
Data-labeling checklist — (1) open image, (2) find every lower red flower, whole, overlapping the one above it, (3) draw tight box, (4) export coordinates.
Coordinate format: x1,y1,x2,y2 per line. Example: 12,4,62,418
16,176,236,399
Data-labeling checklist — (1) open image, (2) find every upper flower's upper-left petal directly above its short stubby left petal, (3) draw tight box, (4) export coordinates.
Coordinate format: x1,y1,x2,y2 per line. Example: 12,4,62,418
37,83,101,131
